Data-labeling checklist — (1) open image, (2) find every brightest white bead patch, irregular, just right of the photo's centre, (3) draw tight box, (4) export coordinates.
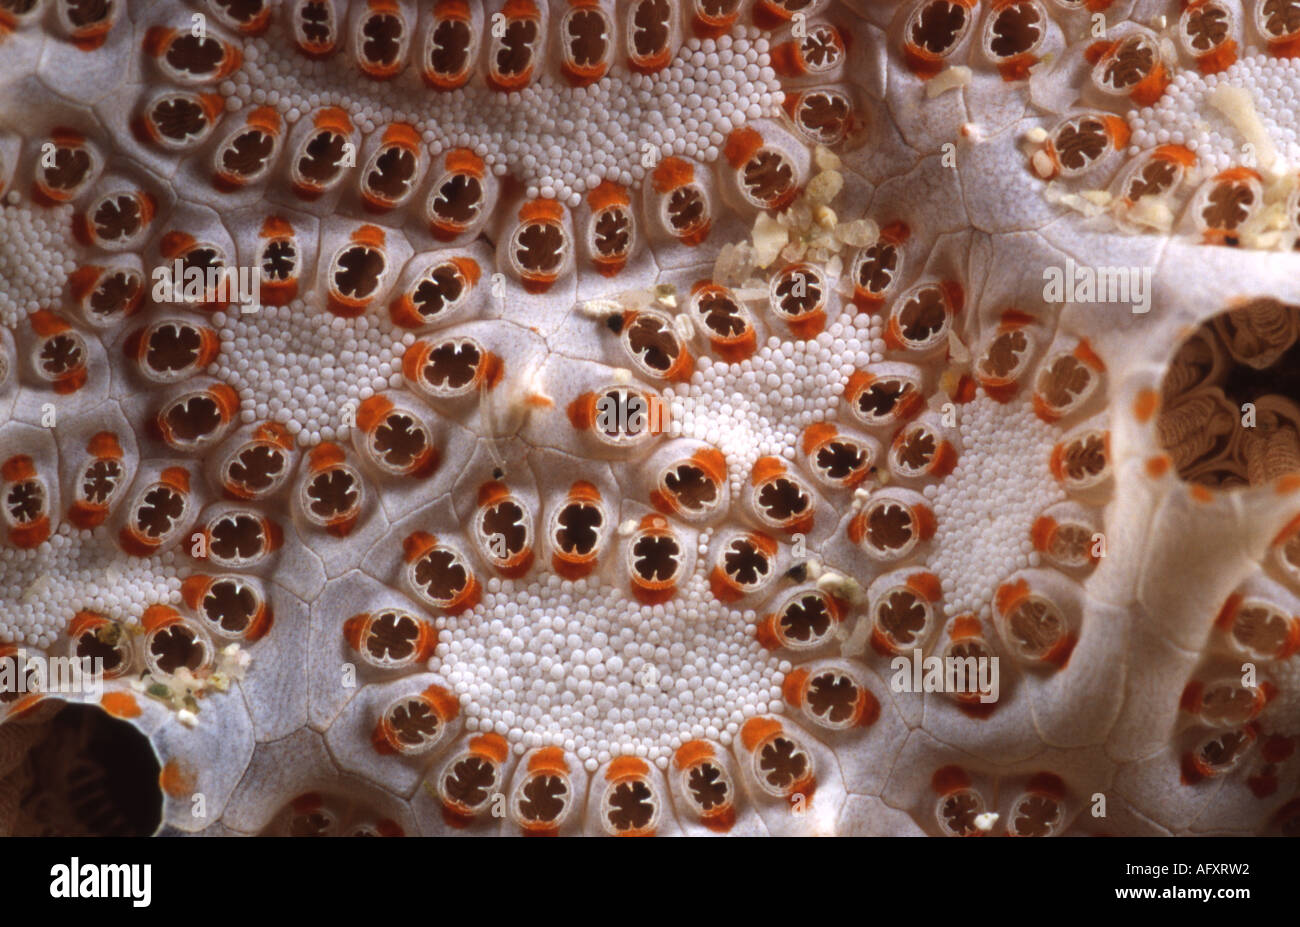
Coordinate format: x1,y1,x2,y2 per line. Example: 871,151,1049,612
663,315,885,494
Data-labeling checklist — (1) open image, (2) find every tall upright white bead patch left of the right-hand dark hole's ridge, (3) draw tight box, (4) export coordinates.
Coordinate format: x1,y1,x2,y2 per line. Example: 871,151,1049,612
924,393,1065,615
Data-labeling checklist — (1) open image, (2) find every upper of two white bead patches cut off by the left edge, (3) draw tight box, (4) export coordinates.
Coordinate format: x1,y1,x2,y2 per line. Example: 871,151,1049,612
0,190,77,329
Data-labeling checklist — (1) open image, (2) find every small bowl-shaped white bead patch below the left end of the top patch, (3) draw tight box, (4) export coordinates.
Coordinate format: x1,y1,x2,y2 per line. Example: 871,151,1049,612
208,294,415,446
